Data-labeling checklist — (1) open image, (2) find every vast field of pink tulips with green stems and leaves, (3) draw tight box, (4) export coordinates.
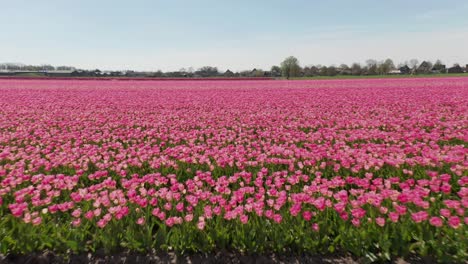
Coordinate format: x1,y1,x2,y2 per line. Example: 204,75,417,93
0,78,468,262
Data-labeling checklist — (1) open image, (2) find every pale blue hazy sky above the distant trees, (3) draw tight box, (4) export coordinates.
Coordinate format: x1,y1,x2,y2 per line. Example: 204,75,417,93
0,0,468,71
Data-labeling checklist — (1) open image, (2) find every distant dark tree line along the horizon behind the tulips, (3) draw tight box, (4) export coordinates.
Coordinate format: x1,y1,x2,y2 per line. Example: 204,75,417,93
0,56,468,79
